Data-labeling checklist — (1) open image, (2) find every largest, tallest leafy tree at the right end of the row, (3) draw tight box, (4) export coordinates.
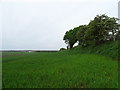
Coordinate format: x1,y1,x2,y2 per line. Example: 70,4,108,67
86,14,119,45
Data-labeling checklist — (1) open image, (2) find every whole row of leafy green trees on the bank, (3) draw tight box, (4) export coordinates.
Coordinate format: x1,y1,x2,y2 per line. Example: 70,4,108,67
63,14,120,48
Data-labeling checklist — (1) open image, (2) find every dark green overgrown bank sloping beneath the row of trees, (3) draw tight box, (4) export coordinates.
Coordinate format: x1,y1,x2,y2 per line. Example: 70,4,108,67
69,40,120,60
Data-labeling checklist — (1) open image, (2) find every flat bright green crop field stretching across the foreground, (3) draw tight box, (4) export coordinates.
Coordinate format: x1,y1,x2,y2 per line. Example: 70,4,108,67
2,52,118,88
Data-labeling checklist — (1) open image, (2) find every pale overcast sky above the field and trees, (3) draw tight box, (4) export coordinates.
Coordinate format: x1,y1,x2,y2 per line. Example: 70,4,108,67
0,0,119,50
